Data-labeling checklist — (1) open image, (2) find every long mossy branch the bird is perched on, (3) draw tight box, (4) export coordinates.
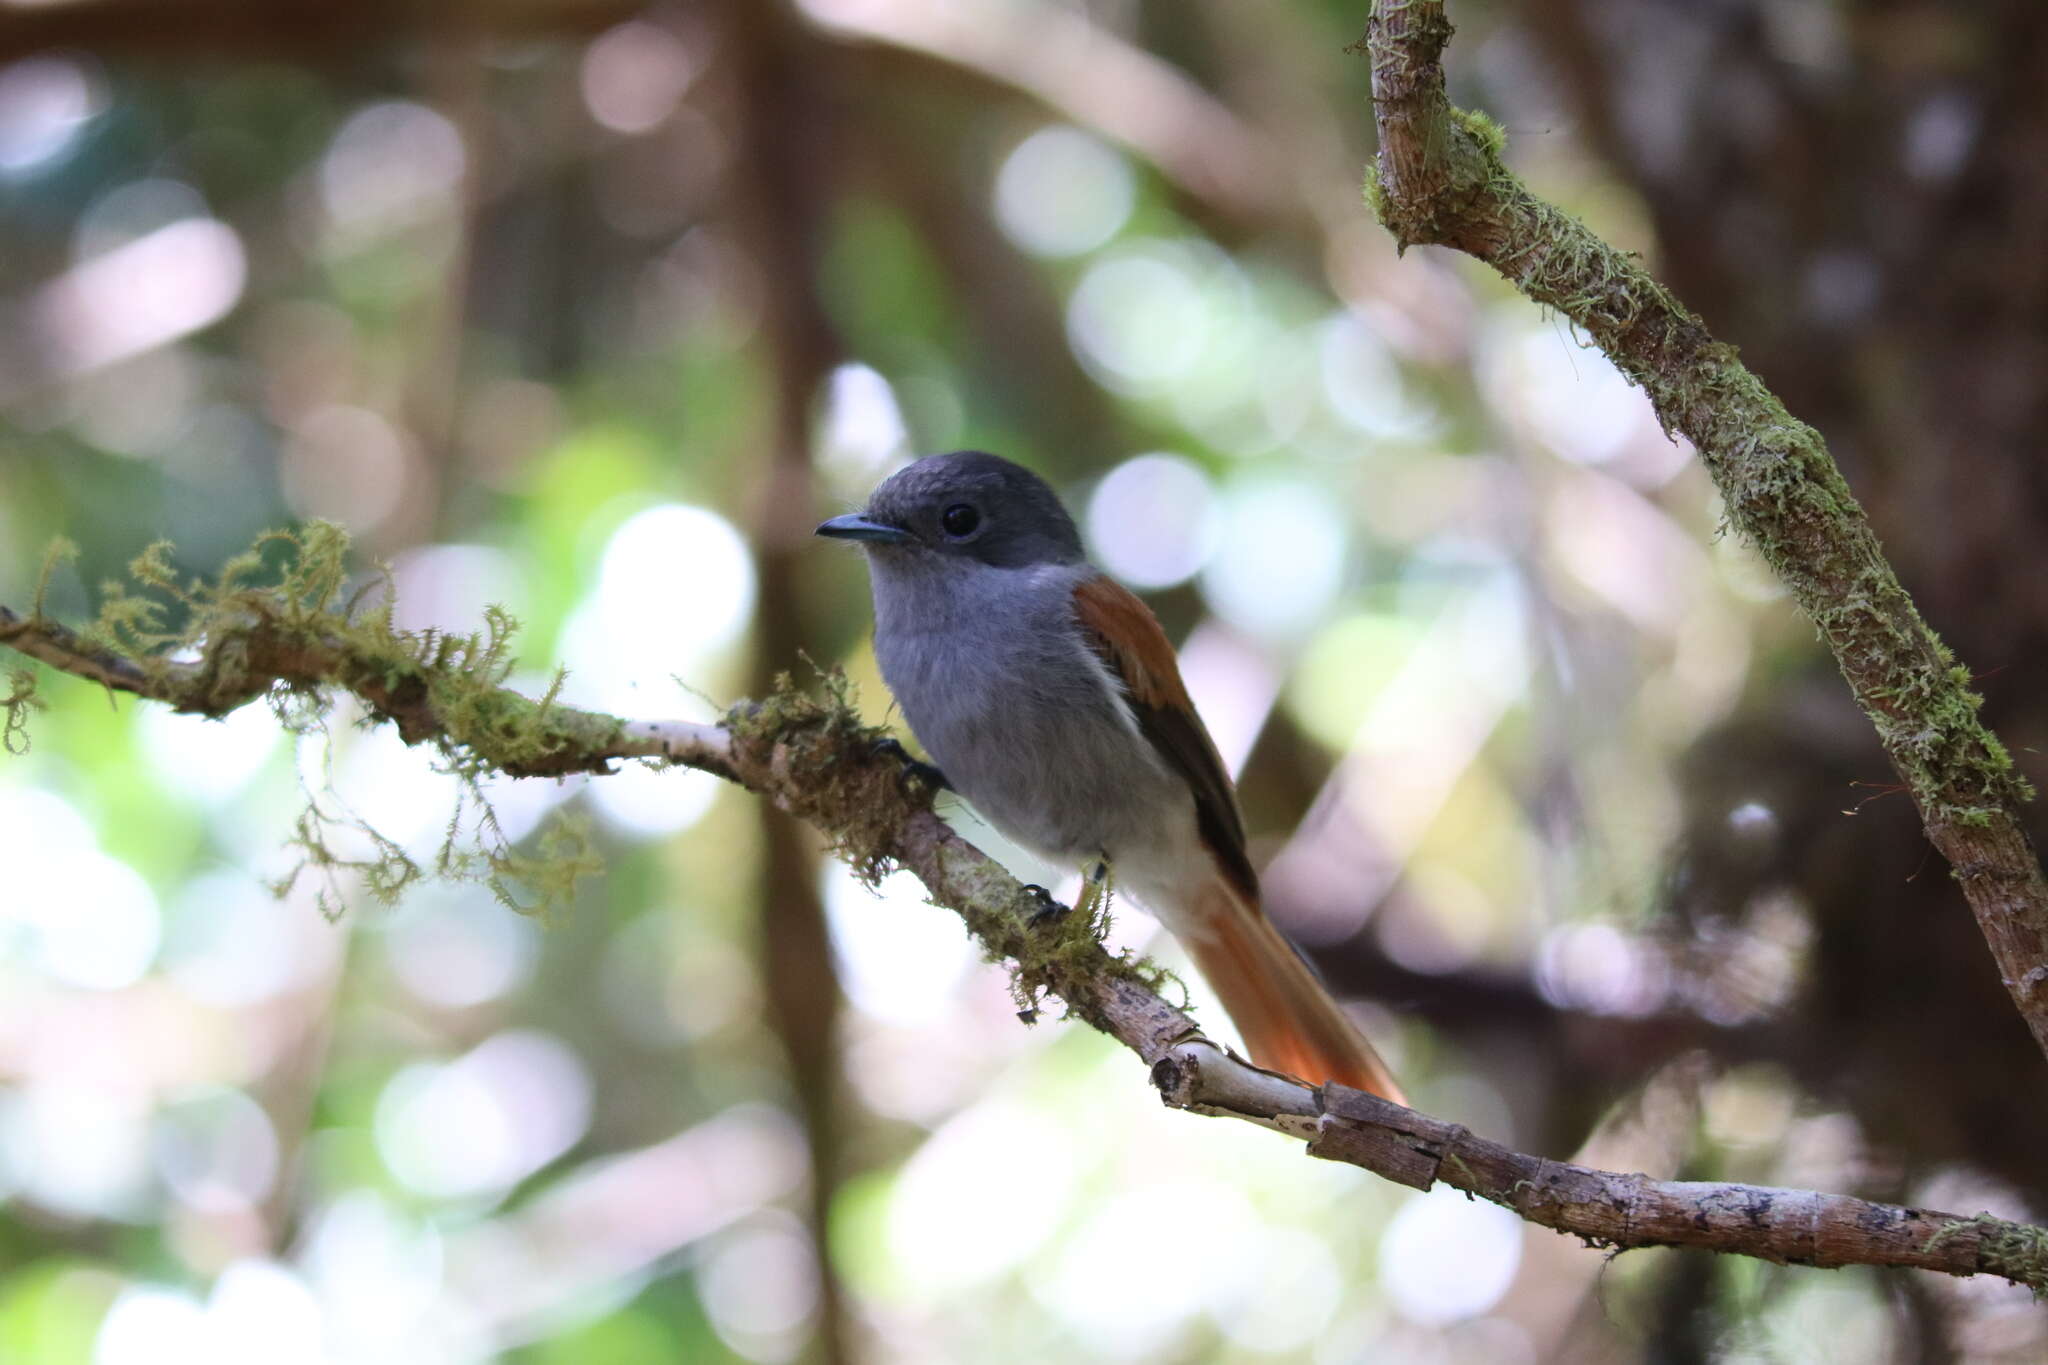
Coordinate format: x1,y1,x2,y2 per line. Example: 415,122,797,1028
0,591,2048,1291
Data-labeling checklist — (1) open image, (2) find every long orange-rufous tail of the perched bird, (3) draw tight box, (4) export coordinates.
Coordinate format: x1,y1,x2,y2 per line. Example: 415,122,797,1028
1182,878,1407,1105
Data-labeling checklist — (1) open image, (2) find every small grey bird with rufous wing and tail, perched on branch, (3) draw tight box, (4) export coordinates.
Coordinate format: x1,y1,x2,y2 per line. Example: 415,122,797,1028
817,450,1405,1103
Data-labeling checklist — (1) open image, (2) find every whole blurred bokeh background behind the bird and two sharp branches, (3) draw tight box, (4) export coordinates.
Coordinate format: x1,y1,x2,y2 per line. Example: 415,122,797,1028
0,0,2048,1365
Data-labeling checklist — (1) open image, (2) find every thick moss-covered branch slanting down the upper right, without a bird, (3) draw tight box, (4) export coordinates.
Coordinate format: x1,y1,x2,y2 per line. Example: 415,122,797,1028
1364,0,2048,1052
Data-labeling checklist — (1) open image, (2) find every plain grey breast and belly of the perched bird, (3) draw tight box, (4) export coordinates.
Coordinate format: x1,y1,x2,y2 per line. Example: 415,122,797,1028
874,557,1176,862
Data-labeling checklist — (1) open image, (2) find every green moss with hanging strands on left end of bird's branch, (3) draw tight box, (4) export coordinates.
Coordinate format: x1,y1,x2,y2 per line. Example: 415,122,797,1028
19,522,621,915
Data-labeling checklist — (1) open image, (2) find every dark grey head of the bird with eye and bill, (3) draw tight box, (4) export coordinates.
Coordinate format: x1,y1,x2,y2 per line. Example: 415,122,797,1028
817,450,1083,569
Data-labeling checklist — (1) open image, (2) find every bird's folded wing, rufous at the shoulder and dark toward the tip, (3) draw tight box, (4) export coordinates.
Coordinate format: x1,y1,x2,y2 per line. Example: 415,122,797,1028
1073,577,1260,905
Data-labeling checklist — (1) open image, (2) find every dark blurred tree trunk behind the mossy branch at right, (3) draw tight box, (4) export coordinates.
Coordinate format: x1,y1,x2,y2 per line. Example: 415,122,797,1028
1526,0,2048,1199
